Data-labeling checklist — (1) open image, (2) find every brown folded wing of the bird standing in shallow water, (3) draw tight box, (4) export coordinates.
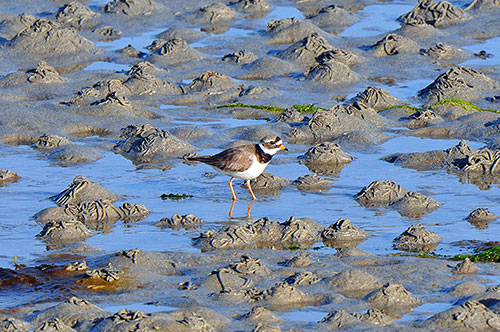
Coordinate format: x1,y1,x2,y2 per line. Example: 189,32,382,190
189,145,256,172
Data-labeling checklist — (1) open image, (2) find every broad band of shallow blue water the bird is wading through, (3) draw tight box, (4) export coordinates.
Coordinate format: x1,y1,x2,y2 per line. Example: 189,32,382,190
0,120,500,267
